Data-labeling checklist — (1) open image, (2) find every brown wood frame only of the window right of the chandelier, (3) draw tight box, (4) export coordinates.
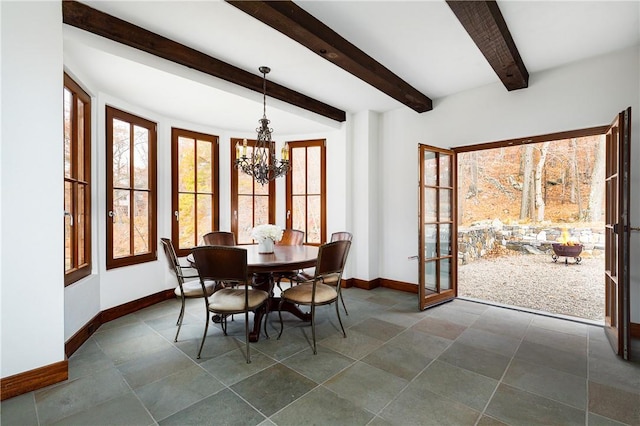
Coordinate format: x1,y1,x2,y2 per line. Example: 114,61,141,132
285,139,327,245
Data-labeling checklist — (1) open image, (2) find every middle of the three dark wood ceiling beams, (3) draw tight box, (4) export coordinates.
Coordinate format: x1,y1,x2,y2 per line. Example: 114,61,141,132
227,0,433,112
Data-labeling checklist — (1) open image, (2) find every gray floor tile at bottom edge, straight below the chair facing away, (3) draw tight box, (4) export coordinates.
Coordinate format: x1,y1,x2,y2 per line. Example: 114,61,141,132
158,389,265,426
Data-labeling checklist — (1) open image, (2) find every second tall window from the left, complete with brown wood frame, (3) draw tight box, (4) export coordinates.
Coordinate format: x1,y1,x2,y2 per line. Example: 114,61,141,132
106,107,157,269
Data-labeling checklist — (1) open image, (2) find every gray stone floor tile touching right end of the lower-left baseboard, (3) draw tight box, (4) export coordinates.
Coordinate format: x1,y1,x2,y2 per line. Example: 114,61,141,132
35,368,131,424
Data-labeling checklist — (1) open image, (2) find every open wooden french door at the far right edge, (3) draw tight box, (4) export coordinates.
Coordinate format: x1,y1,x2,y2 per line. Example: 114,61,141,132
604,108,631,359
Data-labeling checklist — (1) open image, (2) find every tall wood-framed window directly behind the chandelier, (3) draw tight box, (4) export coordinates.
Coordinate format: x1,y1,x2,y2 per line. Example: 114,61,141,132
231,139,276,244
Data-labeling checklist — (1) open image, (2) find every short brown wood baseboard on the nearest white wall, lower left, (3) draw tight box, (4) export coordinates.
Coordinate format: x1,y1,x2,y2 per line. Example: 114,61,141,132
0,359,69,401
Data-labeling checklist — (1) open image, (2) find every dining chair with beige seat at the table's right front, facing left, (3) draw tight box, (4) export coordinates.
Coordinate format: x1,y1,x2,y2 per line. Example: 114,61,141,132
278,240,351,355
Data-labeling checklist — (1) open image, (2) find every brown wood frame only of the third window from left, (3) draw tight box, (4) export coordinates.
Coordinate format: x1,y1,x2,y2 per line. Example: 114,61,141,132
171,128,220,256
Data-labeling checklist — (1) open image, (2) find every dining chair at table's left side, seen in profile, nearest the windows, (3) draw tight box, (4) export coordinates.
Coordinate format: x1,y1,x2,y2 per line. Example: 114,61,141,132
160,238,216,342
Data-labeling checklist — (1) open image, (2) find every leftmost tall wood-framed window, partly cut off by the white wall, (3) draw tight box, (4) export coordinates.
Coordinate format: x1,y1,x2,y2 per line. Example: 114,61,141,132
63,74,91,286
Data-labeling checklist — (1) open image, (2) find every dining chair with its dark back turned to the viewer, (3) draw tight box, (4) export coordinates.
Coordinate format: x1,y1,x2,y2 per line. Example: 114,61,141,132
192,246,269,364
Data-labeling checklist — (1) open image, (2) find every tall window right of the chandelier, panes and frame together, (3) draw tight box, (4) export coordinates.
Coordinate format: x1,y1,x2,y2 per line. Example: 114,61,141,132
286,139,327,244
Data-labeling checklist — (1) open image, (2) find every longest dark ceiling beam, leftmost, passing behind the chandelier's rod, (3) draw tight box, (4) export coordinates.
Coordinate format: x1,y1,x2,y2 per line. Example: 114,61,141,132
62,1,346,122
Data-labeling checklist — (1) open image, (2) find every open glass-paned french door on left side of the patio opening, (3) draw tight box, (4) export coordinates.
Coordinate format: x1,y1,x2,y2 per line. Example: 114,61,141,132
418,145,458,310
